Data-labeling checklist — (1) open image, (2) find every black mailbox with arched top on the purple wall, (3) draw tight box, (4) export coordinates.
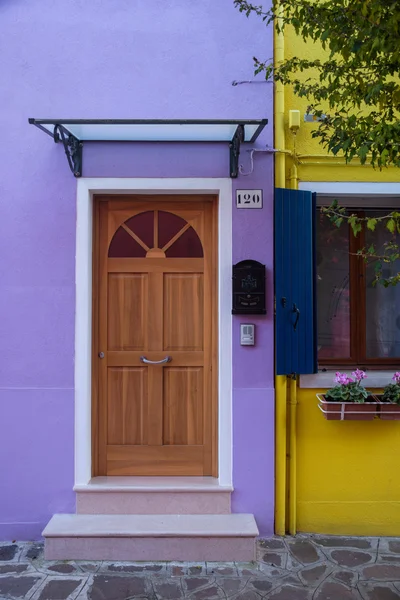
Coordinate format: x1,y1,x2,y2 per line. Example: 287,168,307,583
232,260,267,315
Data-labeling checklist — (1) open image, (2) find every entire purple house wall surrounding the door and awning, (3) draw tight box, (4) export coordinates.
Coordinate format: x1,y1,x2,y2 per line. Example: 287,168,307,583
0,0,273,539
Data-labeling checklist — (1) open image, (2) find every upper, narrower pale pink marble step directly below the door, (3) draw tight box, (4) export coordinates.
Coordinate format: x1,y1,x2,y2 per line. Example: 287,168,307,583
74,477,232,515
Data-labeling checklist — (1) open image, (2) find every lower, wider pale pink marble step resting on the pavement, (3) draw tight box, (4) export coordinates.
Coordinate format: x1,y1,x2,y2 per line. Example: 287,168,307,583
43,514,258,562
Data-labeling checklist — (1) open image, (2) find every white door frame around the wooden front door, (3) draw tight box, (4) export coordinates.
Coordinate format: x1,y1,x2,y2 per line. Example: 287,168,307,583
75,177,232,485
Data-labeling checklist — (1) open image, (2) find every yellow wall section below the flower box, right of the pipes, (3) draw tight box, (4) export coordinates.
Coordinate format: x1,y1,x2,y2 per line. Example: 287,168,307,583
297,389,400,536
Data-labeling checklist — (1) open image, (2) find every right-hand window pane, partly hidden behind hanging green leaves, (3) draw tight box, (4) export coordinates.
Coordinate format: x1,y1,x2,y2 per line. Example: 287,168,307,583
365,211,400,358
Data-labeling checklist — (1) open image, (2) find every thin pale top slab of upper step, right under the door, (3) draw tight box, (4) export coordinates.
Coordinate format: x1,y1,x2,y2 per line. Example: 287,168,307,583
73,476,233,493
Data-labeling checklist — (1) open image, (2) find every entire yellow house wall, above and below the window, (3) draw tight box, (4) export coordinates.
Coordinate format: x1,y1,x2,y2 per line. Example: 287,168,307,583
275,22,400,535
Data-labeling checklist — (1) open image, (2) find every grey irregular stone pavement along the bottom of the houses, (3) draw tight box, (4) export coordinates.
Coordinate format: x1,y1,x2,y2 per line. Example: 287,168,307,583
0,535,400,600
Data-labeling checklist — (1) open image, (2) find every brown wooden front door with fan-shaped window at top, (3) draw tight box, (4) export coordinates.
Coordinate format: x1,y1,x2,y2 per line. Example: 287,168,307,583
93,196,217,476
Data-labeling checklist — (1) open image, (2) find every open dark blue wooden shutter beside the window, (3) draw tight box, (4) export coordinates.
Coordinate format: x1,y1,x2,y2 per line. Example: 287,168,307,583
275,188,317,375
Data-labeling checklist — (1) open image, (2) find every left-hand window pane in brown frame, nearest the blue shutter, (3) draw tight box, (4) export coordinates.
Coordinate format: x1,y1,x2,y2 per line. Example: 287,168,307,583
317,209,350,359
